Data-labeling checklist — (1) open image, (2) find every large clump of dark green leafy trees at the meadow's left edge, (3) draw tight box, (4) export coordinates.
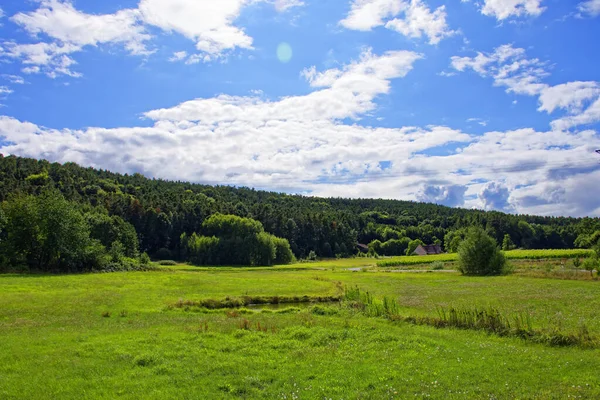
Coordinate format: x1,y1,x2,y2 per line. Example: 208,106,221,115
0,190,139,272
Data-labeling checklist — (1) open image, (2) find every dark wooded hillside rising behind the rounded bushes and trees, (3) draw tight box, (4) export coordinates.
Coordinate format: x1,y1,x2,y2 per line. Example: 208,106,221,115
0,155,600,258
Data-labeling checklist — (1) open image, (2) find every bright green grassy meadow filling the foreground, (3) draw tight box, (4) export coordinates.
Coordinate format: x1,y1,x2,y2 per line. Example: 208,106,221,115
0,259,600,399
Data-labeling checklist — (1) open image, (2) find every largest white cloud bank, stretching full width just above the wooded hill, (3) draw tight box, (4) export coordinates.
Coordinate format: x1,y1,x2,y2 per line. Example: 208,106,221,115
0,46,600,216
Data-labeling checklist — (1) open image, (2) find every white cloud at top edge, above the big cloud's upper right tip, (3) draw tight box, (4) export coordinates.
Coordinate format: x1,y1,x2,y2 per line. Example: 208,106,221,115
340,0,456,44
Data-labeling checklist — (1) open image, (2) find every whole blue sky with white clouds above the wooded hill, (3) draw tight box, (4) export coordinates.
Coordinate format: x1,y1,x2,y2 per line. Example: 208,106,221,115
0,0,600,216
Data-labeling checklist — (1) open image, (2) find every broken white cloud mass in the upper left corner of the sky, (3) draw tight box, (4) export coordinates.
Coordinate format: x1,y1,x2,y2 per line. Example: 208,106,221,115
0,0,303,77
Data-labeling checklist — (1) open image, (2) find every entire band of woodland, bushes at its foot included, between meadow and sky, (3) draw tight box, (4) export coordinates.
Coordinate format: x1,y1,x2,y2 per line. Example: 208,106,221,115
0,155,600,265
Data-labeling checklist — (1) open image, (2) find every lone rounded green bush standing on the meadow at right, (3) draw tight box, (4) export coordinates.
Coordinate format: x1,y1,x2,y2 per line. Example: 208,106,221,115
458,227,506,276
